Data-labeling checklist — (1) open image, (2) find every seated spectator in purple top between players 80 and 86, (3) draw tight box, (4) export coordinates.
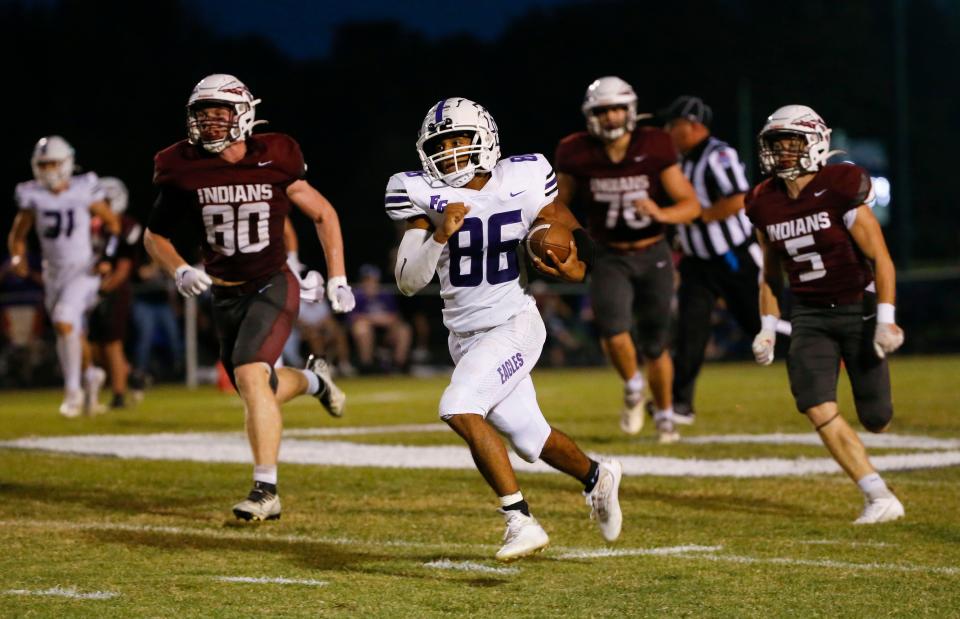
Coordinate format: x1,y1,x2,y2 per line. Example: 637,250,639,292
349,264,413,372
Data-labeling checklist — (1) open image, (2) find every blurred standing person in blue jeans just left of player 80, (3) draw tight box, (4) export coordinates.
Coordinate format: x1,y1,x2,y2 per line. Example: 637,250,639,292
130,254,183,400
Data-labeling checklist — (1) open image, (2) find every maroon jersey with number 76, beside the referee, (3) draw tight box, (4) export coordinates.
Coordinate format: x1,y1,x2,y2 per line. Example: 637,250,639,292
554,127,679,243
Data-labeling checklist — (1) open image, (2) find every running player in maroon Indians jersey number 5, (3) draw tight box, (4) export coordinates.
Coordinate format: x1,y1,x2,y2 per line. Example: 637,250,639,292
746,105,904,524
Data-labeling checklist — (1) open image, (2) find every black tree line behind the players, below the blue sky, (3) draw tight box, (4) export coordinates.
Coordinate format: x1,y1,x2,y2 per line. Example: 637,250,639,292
0,0,960,275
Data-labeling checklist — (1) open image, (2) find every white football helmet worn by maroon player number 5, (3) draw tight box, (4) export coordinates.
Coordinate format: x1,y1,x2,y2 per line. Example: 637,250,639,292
757,105,841,180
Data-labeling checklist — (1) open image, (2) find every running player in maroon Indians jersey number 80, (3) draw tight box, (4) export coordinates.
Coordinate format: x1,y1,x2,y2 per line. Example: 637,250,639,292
144,74,354,520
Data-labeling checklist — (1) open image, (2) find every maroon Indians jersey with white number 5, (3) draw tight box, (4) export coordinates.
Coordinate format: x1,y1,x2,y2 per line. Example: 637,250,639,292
746,163,873,304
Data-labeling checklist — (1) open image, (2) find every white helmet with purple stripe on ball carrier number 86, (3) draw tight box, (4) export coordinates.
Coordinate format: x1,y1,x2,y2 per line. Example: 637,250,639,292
417,97,500,187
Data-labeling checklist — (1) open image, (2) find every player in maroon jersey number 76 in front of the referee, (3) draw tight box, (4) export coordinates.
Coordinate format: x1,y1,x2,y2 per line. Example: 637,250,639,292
555,77,702,443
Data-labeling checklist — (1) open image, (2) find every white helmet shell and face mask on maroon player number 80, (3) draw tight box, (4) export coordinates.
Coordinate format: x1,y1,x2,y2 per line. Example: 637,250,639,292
187,73,267,153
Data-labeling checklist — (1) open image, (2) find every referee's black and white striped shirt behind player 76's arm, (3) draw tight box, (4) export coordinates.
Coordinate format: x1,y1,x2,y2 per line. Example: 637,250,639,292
677,137,753,260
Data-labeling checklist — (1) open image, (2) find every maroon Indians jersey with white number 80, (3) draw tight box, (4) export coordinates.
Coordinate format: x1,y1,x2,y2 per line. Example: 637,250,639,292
147,133,306,281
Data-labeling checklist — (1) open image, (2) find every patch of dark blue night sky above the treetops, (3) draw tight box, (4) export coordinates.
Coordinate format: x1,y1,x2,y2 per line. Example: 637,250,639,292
190,0,584,59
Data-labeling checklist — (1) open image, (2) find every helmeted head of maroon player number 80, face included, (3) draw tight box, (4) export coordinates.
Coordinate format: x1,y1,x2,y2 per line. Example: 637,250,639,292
187,73,266,153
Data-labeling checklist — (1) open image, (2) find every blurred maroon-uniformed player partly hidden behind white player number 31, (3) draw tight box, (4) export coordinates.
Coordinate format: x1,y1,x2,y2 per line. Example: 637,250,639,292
88,176,143,408
